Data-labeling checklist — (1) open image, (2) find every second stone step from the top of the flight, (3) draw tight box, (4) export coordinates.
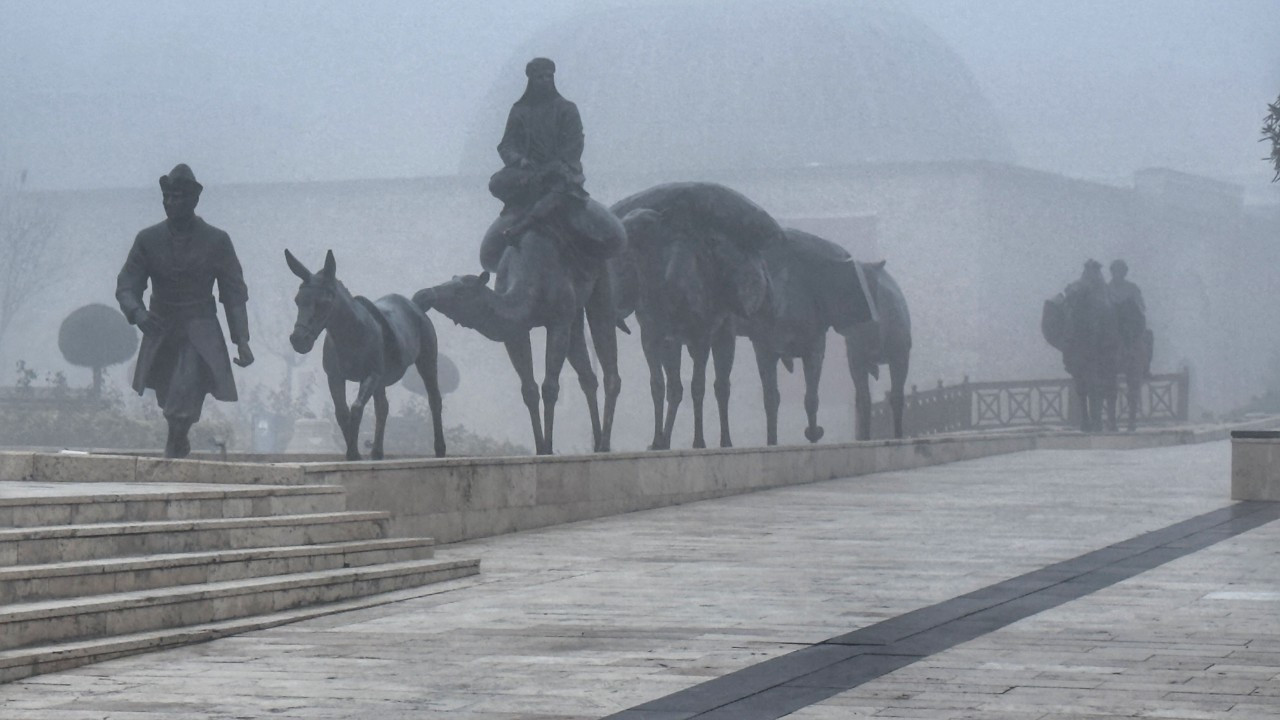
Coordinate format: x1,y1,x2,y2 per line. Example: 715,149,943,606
0,512,389,566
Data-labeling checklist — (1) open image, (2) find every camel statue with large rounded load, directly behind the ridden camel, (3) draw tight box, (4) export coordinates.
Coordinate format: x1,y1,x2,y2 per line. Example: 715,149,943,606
611,182,782,450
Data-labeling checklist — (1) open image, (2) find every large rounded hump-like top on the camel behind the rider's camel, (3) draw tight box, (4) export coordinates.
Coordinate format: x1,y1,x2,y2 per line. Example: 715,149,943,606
611,182,782,250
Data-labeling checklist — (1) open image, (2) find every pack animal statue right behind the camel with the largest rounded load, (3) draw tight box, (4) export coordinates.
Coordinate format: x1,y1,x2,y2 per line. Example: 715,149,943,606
737,228,885,445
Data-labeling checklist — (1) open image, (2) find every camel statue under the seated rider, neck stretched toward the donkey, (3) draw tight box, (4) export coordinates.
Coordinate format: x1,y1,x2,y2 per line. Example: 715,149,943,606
413,200,626,455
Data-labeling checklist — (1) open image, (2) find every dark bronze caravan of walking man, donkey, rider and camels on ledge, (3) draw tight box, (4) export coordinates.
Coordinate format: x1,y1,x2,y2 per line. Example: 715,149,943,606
116,58,911,460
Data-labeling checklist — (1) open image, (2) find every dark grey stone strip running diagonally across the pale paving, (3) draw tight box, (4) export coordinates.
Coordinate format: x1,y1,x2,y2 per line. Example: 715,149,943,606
607,502,1280,720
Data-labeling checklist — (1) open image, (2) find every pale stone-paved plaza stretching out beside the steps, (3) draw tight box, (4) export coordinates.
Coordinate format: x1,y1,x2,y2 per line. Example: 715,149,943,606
0,442,1280,720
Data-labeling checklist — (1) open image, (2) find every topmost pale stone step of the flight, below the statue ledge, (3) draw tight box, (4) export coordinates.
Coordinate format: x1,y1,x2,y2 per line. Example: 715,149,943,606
0,486,347,528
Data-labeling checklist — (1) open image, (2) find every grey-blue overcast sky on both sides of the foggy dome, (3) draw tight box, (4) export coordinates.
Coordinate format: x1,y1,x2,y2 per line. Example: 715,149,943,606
0,0,1280,188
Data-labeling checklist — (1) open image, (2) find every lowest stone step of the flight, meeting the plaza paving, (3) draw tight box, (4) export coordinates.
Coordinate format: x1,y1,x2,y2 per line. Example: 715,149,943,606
0,560,479,683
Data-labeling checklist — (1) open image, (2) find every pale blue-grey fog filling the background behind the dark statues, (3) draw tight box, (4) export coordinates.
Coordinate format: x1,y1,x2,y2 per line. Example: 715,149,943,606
0,0,1280,452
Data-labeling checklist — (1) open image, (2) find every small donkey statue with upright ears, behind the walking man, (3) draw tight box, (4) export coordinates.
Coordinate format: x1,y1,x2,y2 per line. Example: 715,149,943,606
284,250,444,460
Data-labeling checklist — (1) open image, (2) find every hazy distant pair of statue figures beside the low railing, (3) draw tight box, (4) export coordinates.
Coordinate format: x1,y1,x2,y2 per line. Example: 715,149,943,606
1041,259,1155,432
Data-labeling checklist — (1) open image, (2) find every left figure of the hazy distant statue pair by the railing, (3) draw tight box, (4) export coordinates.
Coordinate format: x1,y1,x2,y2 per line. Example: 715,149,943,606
1041,260,1120,433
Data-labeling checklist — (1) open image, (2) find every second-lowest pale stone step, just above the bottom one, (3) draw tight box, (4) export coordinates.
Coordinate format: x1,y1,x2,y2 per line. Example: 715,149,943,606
0,559,479,650
